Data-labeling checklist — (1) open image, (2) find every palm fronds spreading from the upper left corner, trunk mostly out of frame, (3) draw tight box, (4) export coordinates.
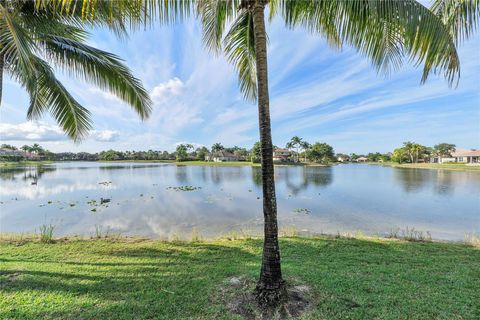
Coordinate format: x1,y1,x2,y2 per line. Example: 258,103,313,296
0,0,151,140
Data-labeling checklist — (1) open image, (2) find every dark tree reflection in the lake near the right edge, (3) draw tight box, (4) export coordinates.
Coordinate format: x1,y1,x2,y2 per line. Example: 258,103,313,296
393,168,456,195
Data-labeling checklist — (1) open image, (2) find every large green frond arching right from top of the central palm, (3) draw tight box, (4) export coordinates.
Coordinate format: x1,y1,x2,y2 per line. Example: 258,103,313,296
279,0,460,84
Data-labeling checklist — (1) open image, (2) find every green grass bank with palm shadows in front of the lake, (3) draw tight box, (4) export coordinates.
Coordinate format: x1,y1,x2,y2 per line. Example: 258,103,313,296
0,238,480,319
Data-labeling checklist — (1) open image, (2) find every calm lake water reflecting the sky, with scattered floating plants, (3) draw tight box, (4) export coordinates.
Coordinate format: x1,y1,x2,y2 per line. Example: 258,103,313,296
0,162,480,240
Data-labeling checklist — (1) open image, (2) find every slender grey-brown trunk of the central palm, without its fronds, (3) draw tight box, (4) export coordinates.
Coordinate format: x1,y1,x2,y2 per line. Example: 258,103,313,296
253,0,285,304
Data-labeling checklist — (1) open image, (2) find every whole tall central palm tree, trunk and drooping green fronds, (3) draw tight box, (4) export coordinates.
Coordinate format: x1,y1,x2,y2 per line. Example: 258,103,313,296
37,0,460,303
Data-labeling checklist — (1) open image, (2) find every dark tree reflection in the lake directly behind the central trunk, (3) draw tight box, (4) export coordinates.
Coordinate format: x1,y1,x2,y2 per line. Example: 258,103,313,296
252,166,333,195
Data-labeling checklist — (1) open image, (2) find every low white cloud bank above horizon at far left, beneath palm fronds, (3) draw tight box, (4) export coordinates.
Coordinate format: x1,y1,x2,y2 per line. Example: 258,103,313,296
0,121,67,141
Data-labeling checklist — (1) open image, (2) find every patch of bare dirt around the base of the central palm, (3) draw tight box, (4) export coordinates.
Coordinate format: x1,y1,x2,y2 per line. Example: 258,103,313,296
219,277,313,320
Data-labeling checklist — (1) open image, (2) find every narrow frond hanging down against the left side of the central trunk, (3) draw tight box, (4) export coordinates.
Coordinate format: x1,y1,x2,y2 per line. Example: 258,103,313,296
223,10,257,101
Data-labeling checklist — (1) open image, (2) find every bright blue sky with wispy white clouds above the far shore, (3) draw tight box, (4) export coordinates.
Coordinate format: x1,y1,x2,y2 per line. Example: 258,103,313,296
0,11,480,153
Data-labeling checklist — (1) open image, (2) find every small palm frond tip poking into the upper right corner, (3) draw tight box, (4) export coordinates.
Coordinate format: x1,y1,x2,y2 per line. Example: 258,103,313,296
431,0,480,43
